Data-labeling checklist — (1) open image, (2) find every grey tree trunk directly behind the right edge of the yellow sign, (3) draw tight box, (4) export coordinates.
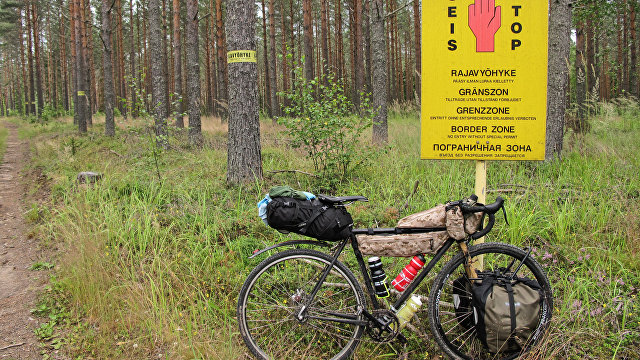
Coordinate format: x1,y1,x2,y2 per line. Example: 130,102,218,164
545,0,572,161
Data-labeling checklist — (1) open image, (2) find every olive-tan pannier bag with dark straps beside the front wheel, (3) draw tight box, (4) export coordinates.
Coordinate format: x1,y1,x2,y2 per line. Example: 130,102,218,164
468,272,542,353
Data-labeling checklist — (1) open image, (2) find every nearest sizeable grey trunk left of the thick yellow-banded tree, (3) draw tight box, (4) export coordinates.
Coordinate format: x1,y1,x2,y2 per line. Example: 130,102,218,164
186,0,202,146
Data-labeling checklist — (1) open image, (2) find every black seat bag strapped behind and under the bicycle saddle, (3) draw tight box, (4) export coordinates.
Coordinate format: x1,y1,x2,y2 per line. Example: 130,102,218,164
267,197,353,241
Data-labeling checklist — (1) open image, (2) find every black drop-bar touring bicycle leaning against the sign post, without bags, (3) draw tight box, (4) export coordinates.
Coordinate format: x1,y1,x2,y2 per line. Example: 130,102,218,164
237,196,553,359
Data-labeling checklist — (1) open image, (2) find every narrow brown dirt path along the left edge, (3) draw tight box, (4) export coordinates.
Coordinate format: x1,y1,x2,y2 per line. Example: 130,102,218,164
0,122,46,360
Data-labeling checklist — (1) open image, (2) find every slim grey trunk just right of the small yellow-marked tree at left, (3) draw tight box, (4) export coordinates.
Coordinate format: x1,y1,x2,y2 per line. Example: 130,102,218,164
102,0,116,136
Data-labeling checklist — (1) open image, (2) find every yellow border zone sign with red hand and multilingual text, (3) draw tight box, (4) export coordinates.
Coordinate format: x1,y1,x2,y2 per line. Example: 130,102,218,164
421,0,549,160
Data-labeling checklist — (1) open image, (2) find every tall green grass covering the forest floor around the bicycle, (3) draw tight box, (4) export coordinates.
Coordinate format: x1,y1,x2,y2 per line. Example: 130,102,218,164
21,106,640,359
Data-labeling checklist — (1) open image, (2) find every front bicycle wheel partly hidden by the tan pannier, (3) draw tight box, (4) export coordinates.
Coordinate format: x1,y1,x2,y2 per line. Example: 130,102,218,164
428,243,553,360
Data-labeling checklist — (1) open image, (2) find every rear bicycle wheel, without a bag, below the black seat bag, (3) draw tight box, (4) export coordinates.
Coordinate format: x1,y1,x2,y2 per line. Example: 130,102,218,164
237,249,366,360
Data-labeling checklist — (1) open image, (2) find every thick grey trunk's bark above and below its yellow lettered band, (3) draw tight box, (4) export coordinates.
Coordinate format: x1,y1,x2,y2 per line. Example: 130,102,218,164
226,0,262,184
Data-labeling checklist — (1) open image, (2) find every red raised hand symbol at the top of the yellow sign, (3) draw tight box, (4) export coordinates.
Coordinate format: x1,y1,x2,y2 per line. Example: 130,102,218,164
469,0,501,52
